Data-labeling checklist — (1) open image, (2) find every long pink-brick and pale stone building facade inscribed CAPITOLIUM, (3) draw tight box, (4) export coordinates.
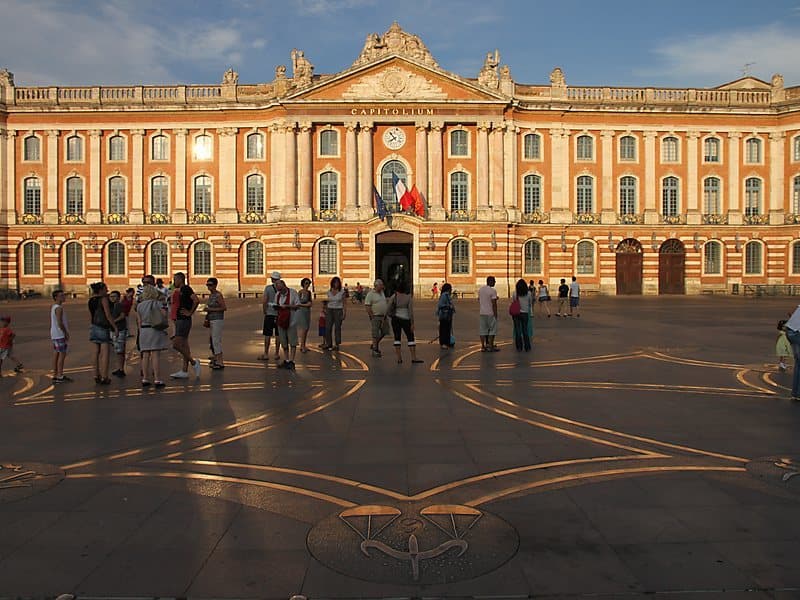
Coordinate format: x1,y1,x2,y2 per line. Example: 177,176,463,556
0,24,800,294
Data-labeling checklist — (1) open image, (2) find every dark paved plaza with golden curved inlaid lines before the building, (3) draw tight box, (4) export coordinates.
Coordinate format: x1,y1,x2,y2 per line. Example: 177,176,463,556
0,296,800,600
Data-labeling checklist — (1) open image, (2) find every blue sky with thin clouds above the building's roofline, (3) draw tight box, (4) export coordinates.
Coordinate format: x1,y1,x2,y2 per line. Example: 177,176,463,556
0,0,800,87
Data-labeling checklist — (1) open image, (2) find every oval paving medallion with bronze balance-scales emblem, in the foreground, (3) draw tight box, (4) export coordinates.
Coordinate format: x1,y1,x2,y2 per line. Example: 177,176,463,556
308,504,519,584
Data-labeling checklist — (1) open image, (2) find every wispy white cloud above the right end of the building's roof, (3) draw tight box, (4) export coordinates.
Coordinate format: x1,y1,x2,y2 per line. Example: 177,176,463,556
636,25,800,87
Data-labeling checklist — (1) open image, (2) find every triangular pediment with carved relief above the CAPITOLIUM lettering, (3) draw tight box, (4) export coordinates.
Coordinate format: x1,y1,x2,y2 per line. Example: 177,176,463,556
287,55,507,102
